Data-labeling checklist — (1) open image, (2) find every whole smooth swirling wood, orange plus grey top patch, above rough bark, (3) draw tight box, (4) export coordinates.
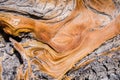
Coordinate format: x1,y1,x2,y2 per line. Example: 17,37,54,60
0,0,120,79
